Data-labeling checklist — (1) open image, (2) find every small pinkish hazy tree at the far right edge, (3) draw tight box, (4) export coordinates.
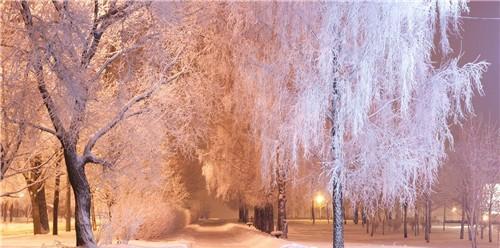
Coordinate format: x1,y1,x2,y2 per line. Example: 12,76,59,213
442,118,500,247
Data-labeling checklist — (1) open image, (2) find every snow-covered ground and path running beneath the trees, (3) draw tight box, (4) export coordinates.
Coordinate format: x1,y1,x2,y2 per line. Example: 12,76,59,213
0,220,500,248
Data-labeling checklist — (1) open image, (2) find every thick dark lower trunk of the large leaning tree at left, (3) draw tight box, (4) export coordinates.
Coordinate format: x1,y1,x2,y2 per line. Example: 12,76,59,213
64,150,97,248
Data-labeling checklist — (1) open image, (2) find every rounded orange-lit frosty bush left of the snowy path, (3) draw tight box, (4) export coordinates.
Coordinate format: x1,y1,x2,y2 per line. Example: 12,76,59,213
96,161,190,243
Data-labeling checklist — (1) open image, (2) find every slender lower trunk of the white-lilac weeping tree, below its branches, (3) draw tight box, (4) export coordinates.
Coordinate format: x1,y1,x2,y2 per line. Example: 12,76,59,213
332,183,344,248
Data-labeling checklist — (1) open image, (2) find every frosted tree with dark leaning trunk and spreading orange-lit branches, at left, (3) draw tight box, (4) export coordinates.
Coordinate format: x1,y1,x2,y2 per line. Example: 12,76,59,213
3,1,191,247
